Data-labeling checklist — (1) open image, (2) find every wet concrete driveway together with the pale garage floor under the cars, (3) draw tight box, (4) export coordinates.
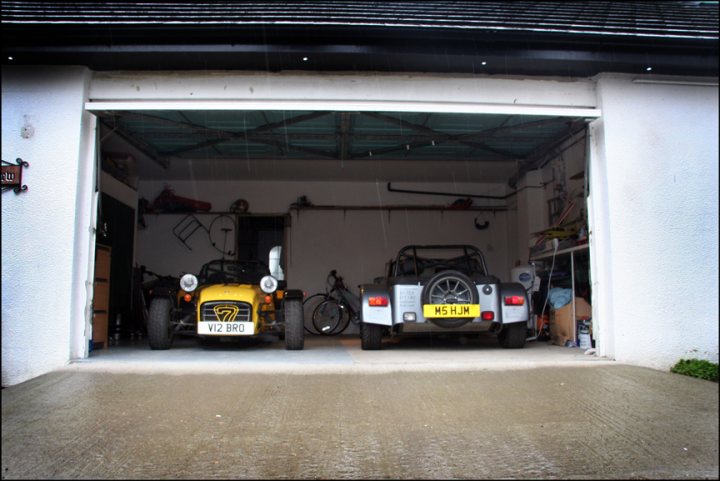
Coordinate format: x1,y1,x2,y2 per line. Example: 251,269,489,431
2,337,719,479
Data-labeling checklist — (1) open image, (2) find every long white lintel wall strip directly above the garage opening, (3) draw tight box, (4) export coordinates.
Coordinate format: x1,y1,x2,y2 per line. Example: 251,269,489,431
90,71,596,111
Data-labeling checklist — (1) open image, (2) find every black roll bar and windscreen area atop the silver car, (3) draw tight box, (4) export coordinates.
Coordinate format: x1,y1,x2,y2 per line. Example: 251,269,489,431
392,245,487,276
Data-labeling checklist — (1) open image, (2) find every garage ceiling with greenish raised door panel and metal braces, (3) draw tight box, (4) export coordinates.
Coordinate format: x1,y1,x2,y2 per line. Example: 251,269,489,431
96,110,586,182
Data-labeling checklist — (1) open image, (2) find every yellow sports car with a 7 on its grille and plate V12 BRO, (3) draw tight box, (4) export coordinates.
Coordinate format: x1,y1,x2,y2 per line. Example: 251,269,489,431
147,255,305,350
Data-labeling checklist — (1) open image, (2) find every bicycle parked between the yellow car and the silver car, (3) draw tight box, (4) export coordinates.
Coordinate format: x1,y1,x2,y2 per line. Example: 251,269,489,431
303,269,360,336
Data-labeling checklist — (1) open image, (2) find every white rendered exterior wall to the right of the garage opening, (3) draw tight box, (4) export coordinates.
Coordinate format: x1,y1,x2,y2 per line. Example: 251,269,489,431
591,75,719,369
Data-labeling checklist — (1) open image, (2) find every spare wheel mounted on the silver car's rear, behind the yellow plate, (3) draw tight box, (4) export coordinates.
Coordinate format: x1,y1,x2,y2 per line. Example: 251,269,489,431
421,270,479,328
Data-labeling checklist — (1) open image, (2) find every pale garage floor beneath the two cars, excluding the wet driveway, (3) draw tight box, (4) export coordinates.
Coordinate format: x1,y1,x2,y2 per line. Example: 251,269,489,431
74,333,609,374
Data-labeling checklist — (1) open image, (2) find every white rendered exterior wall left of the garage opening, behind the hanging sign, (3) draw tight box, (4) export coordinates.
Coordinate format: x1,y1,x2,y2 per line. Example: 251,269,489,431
2,67,95,386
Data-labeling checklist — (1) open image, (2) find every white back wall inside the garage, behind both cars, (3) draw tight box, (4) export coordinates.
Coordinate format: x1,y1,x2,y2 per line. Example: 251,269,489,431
137,181,511,292
